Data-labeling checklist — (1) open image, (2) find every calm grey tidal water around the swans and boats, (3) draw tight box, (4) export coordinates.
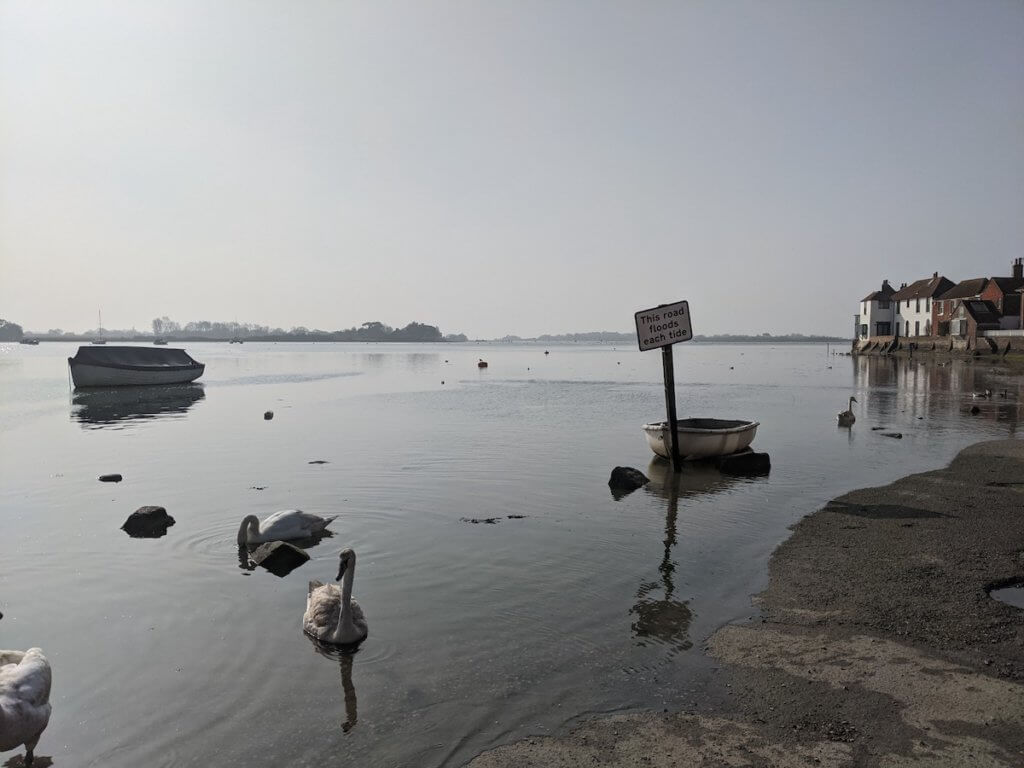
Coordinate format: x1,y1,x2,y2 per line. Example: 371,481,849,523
0,343,1024,768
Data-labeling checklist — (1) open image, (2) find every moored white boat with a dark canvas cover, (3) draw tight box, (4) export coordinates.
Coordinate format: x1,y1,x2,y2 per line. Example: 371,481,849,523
68,347,206,388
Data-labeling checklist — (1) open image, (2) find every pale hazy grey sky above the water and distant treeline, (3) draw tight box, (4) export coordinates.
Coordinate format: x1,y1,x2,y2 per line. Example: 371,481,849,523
0,0,1024,338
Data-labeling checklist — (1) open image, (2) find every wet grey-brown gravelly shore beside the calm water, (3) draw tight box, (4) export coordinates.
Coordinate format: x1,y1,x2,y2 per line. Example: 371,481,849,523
470,440,1024,768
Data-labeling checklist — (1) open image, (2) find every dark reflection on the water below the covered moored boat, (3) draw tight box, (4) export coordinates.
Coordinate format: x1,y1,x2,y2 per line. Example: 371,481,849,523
71,384,206,429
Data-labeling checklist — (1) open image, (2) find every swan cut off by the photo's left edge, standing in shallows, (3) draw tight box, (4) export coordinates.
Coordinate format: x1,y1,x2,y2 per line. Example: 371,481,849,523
0,648,52,766
